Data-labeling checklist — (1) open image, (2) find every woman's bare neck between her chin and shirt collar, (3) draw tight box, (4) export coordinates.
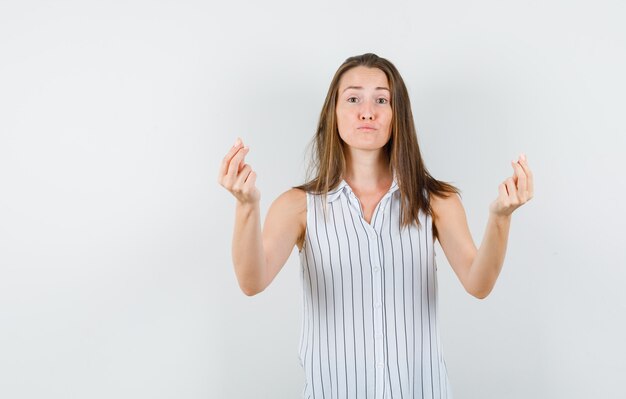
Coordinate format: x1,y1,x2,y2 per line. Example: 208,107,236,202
344,147,393,191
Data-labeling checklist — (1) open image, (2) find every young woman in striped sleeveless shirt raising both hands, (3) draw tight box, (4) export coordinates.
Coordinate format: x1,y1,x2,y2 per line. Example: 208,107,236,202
219,53,533,399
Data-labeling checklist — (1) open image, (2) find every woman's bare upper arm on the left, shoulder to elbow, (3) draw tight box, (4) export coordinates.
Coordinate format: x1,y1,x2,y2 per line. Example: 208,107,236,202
263,188,306,285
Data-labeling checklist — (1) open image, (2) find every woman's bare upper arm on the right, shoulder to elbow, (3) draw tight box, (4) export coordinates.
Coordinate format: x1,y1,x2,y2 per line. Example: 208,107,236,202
431,193,478,287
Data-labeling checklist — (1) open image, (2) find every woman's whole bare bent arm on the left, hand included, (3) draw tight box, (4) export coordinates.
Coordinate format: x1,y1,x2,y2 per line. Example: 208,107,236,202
218,142,306,295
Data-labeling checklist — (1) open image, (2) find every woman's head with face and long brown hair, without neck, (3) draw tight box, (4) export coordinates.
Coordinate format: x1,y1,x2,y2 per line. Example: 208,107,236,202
298,53,458,230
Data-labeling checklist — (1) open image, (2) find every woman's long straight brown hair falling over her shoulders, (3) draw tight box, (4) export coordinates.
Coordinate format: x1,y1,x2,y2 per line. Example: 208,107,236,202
294,53,460,236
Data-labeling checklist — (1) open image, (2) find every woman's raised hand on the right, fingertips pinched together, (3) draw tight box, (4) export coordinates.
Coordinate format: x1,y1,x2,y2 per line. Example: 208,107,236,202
489,154,534,217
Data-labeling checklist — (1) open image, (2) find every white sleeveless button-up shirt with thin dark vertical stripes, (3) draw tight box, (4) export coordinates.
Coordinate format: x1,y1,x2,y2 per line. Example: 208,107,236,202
299,179,452,399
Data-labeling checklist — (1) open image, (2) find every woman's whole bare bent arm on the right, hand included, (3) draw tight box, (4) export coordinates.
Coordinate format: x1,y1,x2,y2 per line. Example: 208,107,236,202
432,157,533,299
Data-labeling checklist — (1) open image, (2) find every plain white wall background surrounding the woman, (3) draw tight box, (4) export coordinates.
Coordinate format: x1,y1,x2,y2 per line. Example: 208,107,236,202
0,0,626,399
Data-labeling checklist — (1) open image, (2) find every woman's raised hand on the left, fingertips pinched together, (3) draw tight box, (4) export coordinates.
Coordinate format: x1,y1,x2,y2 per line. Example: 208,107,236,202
217,138,261,205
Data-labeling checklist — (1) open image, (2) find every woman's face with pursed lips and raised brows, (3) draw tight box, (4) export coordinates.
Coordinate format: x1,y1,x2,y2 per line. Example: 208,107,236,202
336,66,392,150
